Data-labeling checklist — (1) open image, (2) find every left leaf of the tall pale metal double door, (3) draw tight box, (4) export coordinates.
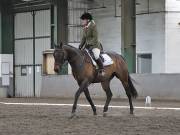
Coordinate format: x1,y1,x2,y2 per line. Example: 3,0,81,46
14,12,33,97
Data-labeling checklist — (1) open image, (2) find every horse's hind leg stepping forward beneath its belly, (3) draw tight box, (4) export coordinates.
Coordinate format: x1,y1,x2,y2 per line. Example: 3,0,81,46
101,81,112,116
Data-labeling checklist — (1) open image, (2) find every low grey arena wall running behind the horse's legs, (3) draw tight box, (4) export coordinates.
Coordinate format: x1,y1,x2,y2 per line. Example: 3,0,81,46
41,74,180,100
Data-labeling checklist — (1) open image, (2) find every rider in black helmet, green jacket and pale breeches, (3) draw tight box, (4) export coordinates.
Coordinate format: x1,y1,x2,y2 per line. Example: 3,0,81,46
79,13,104,75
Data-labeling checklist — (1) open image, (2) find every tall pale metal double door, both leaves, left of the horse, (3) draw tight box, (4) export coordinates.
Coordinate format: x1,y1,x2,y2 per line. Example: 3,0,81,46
14,10,51,97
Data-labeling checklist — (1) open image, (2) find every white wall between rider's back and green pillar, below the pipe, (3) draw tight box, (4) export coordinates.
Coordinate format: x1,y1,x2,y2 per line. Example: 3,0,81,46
95,16,121,54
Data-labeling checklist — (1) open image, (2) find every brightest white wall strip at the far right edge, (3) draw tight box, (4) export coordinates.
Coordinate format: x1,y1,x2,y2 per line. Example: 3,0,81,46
165,0,180,73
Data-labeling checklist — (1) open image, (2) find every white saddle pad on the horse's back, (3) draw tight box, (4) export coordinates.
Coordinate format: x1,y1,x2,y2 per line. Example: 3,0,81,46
86,50,114,66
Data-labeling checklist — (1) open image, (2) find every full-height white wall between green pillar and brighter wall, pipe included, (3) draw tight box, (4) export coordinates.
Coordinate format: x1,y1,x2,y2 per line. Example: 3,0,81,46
136,0,165,73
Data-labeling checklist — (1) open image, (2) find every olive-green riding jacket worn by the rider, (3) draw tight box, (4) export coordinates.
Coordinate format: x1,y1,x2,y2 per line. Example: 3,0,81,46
79,20,101,50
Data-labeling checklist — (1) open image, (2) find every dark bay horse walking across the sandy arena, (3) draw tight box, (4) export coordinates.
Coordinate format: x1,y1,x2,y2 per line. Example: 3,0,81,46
53,44,138,117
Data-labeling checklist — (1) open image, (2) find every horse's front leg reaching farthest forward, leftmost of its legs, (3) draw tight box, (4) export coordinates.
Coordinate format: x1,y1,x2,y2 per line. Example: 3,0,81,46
71,80,89,118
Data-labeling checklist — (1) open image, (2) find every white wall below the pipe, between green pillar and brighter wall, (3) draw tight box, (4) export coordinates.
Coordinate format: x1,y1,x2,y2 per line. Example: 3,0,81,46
136,13,165,73
